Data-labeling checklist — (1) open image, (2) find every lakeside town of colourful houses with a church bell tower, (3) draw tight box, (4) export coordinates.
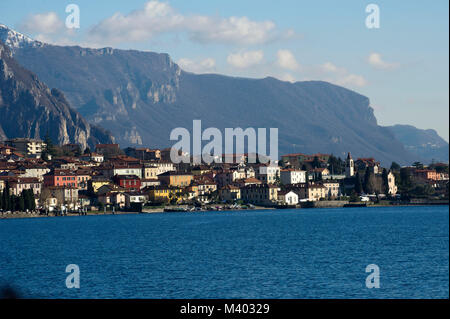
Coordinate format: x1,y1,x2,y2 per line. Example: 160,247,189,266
0,136,449,218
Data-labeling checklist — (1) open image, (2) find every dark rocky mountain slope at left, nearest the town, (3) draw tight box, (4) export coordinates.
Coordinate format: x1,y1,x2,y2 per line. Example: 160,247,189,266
0,41,112,148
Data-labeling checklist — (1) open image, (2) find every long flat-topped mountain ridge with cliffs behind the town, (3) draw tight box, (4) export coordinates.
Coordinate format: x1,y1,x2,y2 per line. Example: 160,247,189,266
0,23,428,165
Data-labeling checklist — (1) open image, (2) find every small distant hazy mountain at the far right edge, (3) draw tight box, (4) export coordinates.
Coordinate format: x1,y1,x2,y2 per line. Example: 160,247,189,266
386,125,449,163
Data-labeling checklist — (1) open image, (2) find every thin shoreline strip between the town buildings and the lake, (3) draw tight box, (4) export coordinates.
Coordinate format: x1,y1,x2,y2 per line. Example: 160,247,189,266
0,202,449,220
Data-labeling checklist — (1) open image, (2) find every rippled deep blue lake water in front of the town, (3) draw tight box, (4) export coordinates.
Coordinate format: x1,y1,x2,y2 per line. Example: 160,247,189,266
0,206,449,298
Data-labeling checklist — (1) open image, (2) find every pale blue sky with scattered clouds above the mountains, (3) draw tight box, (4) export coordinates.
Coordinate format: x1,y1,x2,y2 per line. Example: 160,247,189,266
0,0,449,141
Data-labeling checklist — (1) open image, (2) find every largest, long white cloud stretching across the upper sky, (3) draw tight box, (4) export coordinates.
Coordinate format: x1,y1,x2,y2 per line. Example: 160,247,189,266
89,0,293,45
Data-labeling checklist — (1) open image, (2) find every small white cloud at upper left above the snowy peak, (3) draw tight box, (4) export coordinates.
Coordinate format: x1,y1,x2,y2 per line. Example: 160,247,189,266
20,12,65,34
